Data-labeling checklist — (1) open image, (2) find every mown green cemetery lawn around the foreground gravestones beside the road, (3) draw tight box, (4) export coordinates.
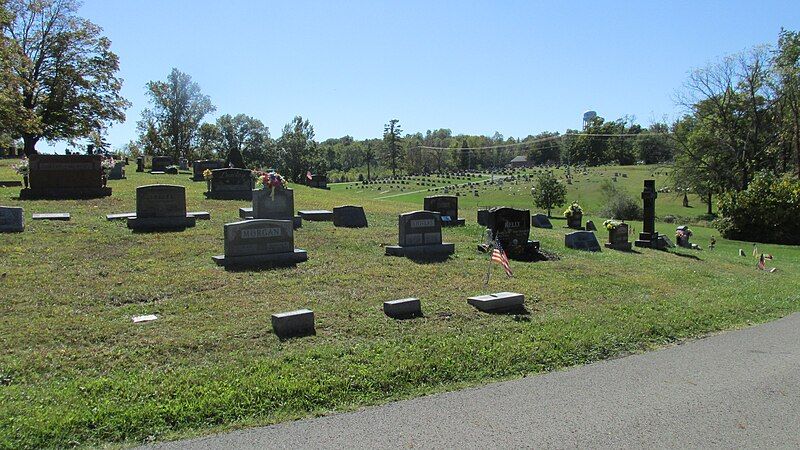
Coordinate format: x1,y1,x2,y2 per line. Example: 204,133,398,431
0,160,800,447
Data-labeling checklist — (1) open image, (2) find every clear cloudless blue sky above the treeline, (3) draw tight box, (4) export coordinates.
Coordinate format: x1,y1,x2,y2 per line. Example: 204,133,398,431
40,0,800,152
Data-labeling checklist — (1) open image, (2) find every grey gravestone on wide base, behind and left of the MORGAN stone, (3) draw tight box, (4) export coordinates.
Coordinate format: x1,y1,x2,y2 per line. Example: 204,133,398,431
128,184,195,231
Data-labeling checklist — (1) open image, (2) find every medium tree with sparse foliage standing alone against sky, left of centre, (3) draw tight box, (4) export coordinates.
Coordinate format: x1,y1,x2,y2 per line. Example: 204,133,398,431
138,68,216,159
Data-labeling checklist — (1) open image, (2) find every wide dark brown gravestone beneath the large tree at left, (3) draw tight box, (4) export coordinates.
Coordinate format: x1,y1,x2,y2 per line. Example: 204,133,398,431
19,155,111,200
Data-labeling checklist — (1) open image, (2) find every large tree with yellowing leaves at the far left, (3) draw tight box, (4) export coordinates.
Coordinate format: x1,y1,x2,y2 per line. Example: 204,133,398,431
3,0,130,155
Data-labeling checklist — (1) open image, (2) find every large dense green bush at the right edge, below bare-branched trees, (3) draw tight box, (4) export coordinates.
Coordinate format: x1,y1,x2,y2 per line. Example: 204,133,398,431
714,171,800,244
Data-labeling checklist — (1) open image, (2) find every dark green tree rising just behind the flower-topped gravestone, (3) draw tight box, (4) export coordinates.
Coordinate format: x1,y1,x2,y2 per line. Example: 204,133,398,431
278,116,317,182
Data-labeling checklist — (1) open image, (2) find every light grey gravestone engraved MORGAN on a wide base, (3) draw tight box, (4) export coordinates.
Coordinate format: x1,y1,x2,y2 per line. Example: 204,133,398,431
212,219,308,267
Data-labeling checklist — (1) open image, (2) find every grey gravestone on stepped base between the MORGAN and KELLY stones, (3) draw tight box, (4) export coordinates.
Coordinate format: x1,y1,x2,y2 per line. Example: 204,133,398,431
386,211,456,258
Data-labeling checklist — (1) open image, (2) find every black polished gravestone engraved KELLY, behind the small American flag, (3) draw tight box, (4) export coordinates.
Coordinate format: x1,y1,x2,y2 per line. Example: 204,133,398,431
480,207,539,260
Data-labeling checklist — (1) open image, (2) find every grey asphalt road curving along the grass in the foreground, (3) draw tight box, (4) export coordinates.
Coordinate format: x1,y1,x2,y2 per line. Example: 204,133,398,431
152,314,800,449
